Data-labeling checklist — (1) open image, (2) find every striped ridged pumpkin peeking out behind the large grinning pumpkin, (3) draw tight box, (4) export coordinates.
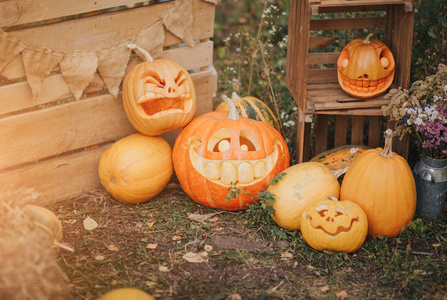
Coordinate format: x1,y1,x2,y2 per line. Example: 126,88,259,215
215,92,281,131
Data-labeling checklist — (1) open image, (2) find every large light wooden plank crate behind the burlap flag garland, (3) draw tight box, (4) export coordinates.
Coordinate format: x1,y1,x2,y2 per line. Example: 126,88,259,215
0,0,217,205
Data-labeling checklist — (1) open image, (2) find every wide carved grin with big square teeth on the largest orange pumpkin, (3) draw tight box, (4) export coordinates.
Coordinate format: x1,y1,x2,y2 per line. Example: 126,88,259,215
189,145,280,186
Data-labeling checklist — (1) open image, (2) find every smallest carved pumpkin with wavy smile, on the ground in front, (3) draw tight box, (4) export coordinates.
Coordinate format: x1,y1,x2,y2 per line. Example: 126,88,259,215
301,197,368,252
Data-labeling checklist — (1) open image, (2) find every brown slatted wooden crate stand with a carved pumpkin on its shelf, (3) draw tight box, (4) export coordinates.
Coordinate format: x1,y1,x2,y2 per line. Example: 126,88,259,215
286,0,414,162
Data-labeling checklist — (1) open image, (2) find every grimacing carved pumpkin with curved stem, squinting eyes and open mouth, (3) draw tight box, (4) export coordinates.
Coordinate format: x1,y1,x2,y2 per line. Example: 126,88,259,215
123,45,196,136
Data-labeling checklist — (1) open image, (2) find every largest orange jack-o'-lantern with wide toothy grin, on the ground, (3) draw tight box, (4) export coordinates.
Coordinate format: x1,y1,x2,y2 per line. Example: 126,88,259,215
173,96,290,210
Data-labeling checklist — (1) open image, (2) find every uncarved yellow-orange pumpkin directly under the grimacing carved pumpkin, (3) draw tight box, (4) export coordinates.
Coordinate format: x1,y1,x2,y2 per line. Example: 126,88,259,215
98,133,174,203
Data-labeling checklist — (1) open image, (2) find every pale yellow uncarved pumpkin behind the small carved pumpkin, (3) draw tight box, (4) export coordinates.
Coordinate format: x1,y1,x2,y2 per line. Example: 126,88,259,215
267,162,340,230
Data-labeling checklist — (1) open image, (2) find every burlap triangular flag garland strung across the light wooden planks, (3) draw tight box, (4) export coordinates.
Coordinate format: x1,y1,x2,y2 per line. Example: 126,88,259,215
0,0,220,101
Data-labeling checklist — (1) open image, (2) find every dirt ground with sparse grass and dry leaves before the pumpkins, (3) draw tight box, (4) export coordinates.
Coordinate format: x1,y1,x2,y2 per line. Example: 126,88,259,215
50,179,447,299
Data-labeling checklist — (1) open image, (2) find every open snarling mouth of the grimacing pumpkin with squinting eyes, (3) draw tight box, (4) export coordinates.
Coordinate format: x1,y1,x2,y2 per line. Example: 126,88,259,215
137,92,193,117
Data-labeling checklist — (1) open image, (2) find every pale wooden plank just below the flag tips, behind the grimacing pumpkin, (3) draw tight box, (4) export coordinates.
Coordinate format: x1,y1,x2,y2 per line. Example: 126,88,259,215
0,69,216,170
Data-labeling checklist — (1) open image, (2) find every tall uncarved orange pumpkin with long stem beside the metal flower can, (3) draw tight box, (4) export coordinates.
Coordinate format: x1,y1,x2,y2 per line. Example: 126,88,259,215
340,130,416,237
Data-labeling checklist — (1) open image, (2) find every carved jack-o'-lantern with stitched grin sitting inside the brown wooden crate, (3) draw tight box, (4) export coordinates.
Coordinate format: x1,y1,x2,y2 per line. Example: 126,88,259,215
337,34,395,99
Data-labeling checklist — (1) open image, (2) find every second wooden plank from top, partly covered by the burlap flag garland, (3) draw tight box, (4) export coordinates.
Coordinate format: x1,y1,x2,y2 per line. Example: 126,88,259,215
6,0,215,51
